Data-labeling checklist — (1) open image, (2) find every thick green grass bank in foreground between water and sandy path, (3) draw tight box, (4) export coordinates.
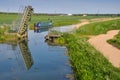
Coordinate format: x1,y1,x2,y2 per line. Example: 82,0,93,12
59,33,120,80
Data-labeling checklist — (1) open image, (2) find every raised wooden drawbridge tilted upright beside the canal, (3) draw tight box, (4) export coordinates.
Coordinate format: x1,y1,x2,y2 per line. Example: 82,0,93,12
17,6,33,39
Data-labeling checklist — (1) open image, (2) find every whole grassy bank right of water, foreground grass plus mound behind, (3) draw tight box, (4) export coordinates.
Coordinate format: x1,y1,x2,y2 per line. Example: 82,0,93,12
55,20,120,80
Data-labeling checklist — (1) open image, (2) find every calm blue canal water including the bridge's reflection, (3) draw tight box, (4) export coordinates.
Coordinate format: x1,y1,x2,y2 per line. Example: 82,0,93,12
0,30,72,80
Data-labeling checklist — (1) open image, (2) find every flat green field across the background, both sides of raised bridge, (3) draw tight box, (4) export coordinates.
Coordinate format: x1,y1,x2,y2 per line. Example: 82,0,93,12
0,13,116,29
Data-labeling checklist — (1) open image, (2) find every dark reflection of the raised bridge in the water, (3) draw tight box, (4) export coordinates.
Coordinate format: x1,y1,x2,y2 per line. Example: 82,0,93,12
19,40,33,69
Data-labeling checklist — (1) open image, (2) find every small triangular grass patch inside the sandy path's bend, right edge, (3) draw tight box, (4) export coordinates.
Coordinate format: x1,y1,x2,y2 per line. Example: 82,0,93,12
108,33,120,49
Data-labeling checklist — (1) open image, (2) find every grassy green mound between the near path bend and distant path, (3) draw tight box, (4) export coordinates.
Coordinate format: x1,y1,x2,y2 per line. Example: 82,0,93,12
76,19,120,35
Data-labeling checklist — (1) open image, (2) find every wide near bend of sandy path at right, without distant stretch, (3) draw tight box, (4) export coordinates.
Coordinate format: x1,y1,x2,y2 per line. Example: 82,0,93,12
89,30,120,67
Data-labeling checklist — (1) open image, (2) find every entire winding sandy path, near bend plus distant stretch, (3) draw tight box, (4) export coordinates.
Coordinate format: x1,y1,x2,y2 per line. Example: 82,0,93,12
71,18,120,67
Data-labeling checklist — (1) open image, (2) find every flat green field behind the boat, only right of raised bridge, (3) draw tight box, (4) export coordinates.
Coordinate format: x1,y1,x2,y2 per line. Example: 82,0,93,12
30,15,114,27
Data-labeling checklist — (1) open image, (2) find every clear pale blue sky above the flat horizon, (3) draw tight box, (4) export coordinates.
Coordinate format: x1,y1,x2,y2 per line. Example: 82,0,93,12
0,0,120,14
